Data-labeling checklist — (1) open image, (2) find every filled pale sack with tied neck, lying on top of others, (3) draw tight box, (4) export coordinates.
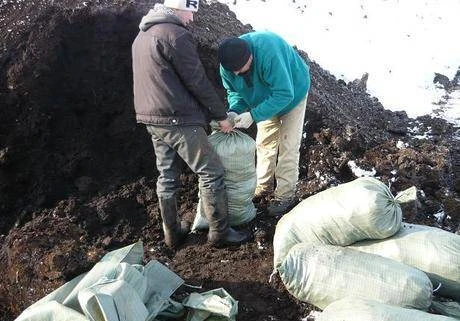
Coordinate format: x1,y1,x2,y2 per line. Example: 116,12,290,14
273,177,406,269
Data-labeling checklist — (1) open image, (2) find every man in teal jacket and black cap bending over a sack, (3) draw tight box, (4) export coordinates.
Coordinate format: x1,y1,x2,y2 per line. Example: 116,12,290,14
219,32,310,216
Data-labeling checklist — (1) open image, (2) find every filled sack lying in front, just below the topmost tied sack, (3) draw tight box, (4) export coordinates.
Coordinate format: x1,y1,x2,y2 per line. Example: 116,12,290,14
278,243,433,310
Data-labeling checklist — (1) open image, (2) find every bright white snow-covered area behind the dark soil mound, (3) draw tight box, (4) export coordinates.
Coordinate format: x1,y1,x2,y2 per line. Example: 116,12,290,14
219,0,460,125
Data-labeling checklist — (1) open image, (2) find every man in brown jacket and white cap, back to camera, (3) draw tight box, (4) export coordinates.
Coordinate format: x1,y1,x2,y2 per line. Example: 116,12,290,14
132,0,248,248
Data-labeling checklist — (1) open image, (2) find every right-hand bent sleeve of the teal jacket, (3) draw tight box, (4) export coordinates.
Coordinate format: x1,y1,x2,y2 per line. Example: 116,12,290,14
251,55,294,122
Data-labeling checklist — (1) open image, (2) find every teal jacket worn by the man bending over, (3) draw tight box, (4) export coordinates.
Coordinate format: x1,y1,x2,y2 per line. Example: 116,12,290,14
220,31,310,122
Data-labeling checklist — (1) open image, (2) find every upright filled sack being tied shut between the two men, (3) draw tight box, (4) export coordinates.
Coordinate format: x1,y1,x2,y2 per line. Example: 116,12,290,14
192,130,257,230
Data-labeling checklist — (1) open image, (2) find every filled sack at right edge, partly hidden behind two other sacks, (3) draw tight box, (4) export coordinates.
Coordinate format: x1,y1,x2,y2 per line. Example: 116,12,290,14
350,224,460,300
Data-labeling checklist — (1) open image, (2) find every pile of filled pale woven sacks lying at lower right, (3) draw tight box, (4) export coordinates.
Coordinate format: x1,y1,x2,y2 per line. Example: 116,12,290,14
273,177,460,321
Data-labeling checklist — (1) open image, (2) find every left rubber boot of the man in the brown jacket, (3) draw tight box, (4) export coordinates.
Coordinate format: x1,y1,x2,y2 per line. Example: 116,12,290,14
158,196,190,248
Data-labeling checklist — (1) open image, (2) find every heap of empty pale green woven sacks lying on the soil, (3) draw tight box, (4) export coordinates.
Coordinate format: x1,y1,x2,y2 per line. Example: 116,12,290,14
16,242,237,321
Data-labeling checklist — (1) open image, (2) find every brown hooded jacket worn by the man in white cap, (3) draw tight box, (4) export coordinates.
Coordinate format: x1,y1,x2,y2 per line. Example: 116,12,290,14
132,10,227,125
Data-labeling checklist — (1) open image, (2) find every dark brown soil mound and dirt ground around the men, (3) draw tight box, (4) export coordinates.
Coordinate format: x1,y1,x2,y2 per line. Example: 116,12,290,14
0,0,460,321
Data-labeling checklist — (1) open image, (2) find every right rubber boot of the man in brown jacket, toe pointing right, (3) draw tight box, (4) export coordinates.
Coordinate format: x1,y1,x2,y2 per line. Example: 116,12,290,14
201,189,250,246
